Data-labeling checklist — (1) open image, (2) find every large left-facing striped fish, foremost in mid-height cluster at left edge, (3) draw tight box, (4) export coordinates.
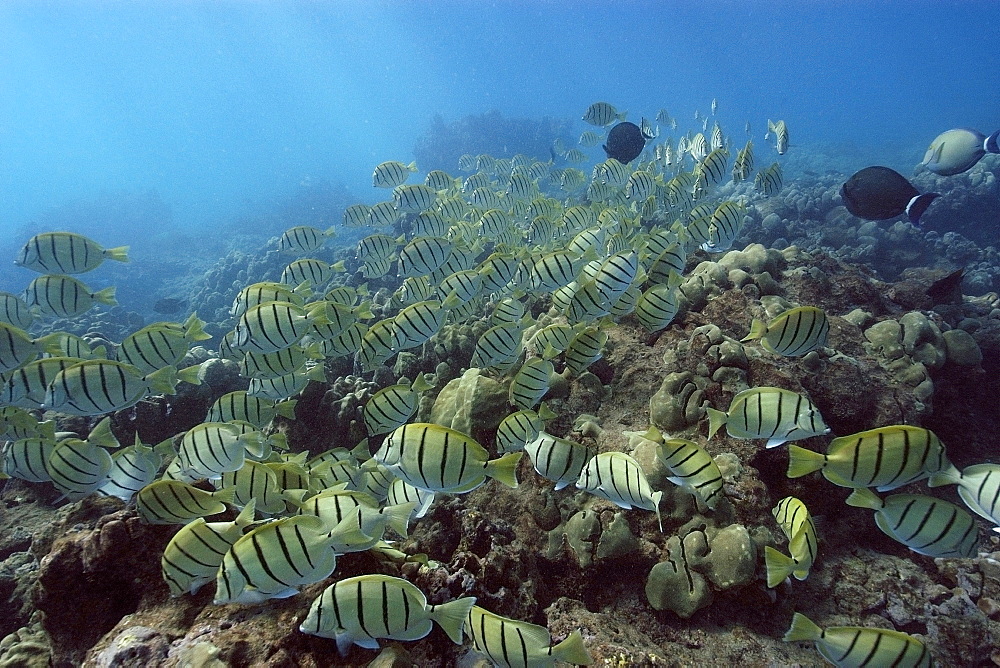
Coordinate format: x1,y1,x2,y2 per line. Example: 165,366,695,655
44,360,201,415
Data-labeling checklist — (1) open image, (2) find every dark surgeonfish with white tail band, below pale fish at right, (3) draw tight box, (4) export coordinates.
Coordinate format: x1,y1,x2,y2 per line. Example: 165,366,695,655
840,167,940,225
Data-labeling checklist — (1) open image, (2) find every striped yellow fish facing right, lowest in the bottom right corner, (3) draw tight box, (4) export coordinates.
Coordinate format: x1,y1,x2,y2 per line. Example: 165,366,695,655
784,612,934,668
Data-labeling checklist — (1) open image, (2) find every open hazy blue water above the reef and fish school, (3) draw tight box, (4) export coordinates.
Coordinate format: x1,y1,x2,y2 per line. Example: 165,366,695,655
0,0,1000,280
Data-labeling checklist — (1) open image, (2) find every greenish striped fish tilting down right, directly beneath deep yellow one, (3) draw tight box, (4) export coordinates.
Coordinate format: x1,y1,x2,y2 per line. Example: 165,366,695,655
847,487,979,559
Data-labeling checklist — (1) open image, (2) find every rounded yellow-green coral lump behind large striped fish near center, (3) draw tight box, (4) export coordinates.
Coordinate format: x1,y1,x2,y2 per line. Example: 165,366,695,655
430,368,508,437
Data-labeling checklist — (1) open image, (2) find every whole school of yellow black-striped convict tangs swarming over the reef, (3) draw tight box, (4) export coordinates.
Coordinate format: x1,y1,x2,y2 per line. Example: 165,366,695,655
0,101,1000,666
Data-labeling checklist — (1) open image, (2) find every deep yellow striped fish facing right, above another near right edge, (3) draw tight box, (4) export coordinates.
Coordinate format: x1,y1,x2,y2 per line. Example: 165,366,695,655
788,425,951,492
